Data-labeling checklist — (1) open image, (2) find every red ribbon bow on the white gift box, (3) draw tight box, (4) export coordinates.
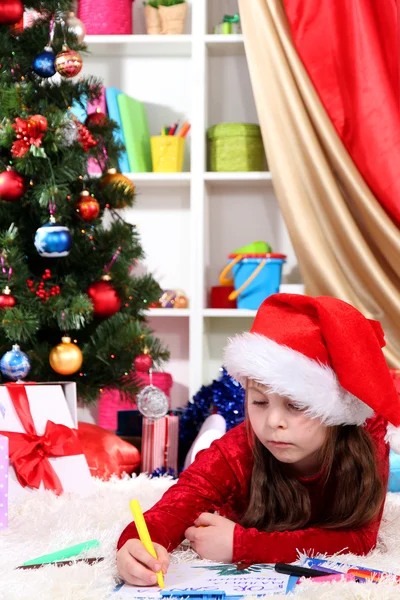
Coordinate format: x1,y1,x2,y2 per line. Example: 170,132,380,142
0,384,82,494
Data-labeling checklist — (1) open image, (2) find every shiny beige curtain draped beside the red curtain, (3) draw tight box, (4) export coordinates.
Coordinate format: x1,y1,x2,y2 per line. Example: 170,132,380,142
239,0,400,367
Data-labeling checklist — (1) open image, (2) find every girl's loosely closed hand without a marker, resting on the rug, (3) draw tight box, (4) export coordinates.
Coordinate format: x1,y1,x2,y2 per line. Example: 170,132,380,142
185,513,235,563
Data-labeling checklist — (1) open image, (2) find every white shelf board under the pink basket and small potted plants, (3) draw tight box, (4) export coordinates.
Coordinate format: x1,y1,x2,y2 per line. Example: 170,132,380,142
85,35,192,58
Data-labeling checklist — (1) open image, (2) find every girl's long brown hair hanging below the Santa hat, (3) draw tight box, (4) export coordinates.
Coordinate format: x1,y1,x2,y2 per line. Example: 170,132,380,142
241,422,385,531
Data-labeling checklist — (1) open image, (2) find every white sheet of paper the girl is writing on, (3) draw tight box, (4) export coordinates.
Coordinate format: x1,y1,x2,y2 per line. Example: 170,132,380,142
115,563,289,600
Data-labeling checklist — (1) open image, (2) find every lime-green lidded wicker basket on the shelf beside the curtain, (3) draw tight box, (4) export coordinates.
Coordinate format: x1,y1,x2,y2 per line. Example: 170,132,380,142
207,123,266,171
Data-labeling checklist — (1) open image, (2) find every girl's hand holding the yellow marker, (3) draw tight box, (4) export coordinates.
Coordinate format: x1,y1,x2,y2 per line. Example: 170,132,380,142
117,540,169,587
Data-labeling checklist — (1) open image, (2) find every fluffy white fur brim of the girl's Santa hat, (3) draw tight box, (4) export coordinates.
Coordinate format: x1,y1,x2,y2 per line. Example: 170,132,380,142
224,333,374,425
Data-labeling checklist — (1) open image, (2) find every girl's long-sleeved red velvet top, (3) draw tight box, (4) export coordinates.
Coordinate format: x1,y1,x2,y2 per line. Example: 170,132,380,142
118,417,389,564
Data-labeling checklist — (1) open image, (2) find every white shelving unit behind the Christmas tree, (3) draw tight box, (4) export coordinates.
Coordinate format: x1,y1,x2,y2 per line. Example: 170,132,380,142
84,0,303,406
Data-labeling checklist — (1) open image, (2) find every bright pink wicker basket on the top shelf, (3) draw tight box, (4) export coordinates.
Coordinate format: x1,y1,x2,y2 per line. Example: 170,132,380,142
78,0,133,35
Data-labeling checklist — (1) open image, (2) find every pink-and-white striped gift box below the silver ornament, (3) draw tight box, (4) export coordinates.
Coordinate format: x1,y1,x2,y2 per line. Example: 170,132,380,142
141,415,179,474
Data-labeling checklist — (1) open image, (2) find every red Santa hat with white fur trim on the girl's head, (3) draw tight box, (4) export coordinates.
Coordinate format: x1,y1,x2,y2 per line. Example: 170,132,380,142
225,294,400,454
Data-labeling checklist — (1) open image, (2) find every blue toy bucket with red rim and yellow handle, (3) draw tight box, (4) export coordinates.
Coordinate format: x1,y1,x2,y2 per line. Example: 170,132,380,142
229,254,286,310
